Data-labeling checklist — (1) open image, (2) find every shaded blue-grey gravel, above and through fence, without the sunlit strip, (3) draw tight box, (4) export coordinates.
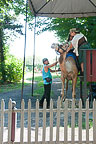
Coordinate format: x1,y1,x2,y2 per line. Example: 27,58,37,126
0,78,80,127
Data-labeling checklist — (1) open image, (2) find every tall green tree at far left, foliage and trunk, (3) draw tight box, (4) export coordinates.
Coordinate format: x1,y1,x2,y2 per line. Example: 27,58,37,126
0,0,32,82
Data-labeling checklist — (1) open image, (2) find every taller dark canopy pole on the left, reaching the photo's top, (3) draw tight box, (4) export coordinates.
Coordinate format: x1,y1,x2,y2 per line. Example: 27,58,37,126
21,0,28,100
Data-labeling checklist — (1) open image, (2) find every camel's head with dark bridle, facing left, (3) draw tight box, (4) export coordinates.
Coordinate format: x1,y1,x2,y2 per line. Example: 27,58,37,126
51,43,69,54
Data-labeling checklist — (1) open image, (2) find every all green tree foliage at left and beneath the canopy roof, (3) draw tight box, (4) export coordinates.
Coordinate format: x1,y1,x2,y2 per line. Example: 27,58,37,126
0,0,96,81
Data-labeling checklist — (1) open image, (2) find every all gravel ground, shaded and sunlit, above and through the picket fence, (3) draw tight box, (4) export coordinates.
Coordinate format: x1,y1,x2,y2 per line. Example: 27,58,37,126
0,78,93,142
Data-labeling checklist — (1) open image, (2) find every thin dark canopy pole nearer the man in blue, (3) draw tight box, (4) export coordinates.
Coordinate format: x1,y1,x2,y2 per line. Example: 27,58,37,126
32,16,36,96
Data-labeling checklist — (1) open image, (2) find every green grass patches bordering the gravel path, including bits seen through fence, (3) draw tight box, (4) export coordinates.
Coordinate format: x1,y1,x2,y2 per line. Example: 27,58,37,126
0,74,93,129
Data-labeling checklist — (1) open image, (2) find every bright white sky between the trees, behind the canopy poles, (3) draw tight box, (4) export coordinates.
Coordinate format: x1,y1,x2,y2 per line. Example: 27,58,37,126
10,30,58,61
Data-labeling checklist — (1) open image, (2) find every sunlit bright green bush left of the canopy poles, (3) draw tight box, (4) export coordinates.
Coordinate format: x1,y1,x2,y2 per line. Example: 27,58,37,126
6,56,22,82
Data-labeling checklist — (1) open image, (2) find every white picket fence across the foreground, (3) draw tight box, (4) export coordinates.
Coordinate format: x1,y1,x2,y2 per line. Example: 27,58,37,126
0,98,96,144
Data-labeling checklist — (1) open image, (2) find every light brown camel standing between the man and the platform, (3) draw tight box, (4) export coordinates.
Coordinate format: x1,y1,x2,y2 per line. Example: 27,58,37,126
51,43,78,103
